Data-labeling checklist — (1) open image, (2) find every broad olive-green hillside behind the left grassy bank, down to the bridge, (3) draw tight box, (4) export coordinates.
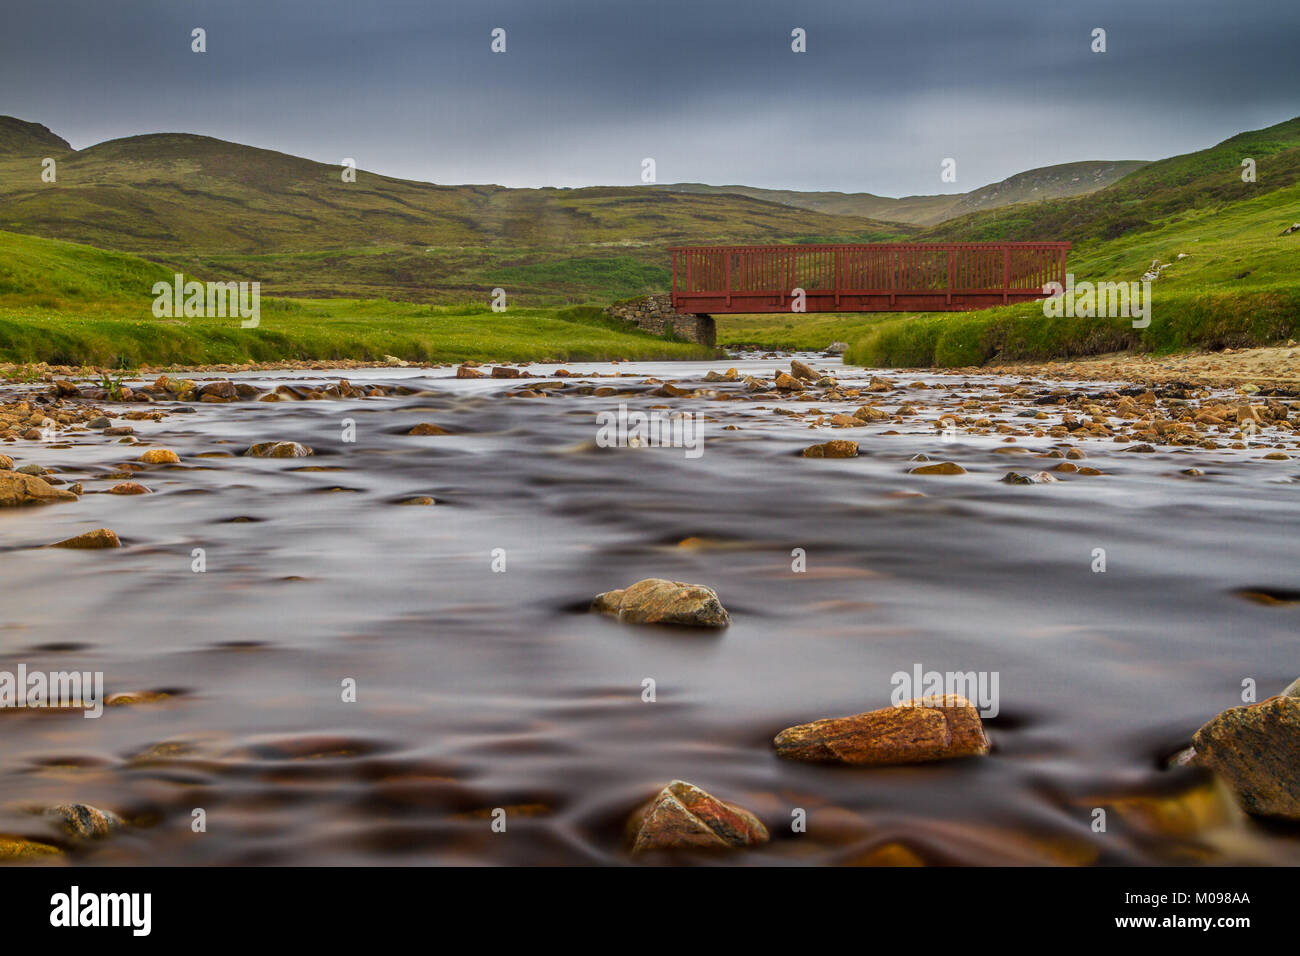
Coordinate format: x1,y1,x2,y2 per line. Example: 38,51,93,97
0,118,909,304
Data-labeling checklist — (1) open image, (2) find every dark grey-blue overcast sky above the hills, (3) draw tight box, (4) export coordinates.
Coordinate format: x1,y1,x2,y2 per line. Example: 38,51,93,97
0,0,1300,195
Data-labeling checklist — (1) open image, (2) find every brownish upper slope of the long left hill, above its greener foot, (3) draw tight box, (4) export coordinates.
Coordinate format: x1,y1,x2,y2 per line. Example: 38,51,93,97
0,118,914,260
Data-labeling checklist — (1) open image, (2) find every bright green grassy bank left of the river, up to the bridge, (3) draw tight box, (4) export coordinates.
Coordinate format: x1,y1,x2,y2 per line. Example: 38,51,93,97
0,233,712,368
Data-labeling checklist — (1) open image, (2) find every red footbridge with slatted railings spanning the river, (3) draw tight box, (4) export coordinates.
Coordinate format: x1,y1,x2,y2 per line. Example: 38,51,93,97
670,242,1070,315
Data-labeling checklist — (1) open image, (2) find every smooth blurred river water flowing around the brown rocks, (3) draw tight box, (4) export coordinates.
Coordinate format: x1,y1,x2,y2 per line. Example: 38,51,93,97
0,360,1300,865
